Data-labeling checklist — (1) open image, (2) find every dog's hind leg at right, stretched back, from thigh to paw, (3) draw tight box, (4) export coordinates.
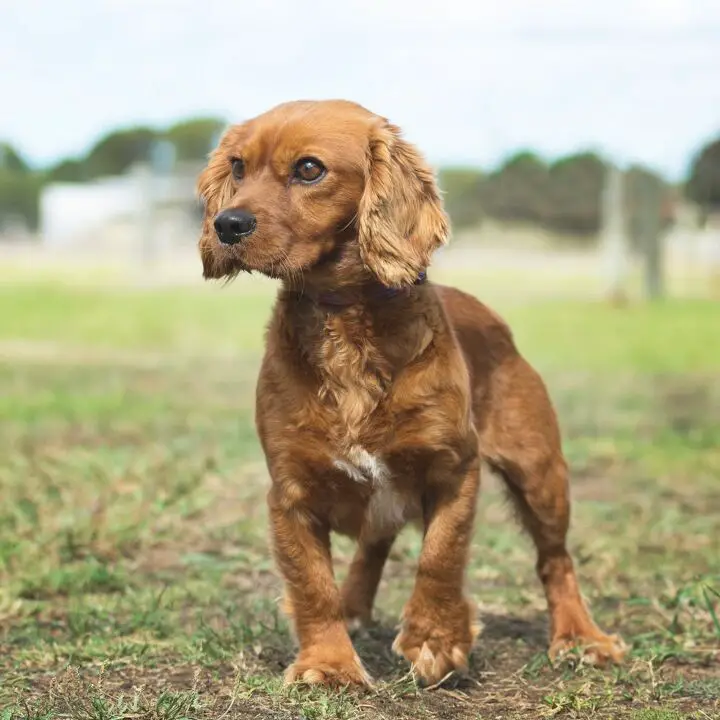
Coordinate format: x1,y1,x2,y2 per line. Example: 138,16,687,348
480,360,626,665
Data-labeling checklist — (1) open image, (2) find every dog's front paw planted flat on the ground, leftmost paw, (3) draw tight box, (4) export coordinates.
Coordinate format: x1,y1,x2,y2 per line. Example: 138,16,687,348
285,646,372,687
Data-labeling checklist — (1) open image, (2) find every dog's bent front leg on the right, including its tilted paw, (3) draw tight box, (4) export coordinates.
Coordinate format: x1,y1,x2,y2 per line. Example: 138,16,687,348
393,448,480,683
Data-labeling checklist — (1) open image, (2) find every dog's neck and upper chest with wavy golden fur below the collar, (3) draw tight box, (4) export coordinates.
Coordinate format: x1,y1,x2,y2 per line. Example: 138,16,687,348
277,274,438,448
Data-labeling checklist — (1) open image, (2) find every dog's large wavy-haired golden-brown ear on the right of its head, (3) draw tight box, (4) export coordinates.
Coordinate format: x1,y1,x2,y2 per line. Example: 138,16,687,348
357,120,449,287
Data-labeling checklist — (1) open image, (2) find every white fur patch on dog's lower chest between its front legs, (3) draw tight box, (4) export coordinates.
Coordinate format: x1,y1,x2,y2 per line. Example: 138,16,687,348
333,445,418,541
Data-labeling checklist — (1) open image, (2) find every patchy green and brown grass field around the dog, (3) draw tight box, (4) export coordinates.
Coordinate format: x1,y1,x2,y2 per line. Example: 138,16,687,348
0,277,720,720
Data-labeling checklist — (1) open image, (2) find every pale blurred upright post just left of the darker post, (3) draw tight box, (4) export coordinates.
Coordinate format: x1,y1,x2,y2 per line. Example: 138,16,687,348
600,163,628,305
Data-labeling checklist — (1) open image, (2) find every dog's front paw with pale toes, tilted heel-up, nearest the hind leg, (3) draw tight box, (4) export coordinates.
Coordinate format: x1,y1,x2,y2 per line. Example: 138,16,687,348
393,600,477,685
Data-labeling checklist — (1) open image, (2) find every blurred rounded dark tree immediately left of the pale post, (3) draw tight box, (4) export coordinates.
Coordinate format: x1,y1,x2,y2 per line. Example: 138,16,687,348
545,152,606,236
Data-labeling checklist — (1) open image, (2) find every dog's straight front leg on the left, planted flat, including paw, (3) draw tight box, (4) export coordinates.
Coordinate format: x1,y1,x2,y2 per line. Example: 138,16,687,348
268,491,370,685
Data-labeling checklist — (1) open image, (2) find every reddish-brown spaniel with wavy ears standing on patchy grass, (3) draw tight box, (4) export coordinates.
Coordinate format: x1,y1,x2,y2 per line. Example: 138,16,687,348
198,100,625,685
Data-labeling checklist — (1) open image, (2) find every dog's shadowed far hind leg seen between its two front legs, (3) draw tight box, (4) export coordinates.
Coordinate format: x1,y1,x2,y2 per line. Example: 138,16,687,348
341,536,395,628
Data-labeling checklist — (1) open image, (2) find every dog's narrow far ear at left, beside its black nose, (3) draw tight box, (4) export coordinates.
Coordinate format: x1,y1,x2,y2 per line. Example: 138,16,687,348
197,143,232,280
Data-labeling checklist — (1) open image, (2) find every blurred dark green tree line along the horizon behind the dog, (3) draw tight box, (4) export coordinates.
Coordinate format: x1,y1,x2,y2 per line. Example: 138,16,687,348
0,117,720,240
